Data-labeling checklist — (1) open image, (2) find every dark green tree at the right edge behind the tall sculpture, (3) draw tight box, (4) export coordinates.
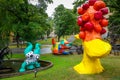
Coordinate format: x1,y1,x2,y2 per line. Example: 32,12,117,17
105,0,120,34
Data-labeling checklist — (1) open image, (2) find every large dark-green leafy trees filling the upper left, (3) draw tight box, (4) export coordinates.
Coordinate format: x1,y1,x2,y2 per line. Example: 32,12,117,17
0,0,52,47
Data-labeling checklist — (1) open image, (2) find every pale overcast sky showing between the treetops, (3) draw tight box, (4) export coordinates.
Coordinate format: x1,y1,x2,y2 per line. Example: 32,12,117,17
46,0,75,16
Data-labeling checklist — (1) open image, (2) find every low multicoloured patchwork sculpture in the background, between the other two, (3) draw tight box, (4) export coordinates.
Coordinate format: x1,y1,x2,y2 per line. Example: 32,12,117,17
52,38,72,54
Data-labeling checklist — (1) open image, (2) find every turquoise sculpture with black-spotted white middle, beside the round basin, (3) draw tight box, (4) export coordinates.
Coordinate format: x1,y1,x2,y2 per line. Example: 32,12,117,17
19,42,40,72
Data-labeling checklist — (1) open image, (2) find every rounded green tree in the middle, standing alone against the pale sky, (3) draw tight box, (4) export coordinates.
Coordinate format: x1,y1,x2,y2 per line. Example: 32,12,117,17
54,4,76,41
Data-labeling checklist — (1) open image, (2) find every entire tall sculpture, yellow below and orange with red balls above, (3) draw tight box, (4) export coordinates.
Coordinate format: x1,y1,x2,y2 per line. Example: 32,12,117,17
74,0,111,74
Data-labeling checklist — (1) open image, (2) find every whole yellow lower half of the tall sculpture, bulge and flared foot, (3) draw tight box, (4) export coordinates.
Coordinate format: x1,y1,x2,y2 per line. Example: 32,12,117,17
74,39,111,74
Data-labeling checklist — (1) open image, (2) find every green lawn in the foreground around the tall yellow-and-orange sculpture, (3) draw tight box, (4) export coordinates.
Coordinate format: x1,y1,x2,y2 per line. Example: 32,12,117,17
1,54,120,80
